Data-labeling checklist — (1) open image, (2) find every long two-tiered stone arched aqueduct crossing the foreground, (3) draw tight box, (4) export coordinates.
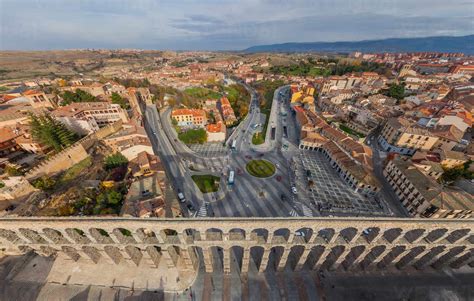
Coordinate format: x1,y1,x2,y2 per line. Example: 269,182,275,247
0,218,474,273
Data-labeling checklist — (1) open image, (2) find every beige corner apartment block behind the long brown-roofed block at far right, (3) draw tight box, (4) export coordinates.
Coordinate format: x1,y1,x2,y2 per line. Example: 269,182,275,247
379,117,439,155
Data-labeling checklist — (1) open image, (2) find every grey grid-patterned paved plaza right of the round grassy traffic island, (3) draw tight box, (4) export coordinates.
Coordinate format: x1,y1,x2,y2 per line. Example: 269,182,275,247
295,151,383,215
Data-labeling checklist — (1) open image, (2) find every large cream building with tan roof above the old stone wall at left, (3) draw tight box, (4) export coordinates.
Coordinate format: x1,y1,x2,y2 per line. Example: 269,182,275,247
52,102,128,135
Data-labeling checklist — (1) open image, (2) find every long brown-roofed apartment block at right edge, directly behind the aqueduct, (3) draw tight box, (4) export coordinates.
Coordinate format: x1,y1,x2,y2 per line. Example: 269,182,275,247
383,158,474,218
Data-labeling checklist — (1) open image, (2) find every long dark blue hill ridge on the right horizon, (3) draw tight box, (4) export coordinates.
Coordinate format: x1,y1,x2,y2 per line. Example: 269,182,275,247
244,35,474,54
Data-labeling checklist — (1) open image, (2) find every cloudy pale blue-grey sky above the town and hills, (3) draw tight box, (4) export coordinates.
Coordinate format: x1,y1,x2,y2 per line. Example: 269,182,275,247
0,0,474,50
